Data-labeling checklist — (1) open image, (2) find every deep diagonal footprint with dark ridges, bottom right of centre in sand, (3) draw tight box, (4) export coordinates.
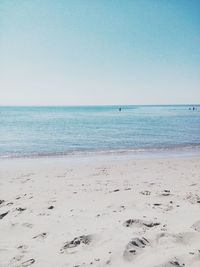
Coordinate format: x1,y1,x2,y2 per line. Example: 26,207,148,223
123,237,150,261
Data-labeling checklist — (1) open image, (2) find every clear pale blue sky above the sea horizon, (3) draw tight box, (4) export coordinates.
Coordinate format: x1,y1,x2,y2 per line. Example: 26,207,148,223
0,0,200,105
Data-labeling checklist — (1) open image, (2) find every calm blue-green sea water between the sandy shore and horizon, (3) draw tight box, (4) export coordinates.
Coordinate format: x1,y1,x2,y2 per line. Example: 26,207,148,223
0,105,200,158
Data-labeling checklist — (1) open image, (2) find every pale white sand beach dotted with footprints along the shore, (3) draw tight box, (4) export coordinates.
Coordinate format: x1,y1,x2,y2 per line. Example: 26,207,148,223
0,157,200,267
